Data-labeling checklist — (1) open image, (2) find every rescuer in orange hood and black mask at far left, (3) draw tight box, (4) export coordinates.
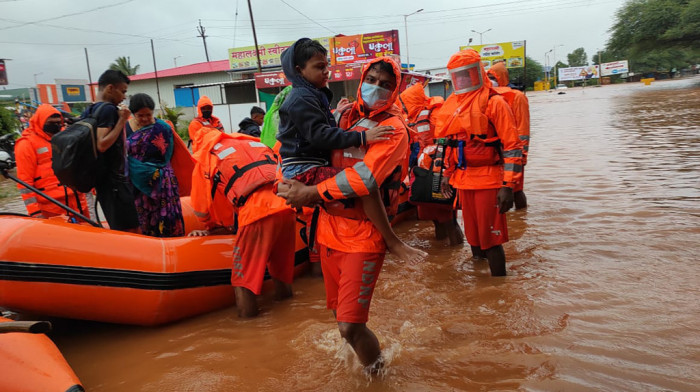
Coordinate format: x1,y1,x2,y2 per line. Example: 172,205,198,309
15,104,89,218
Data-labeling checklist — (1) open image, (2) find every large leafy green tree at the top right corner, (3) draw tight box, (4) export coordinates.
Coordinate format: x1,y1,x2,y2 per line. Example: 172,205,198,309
603,0,700,72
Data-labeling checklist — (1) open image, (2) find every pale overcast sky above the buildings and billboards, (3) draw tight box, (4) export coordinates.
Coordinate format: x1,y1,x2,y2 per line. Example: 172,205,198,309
0,0,625,88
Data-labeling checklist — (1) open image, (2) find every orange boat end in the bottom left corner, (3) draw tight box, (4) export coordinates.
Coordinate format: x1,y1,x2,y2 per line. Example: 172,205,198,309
0,317,84,392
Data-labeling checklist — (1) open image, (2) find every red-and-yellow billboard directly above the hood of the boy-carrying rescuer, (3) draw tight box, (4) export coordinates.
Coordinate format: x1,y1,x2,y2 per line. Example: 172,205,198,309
331,30,399,65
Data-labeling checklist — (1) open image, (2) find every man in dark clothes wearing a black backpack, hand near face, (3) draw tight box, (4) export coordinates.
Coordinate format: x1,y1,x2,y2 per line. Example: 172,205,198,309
89,70,139,233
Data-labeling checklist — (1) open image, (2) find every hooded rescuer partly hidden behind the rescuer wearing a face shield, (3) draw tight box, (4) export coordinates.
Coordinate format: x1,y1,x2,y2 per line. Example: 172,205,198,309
398,83,464,245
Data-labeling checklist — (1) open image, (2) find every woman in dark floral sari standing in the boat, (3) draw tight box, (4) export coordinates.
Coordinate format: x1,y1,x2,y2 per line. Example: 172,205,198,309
126,94,185,237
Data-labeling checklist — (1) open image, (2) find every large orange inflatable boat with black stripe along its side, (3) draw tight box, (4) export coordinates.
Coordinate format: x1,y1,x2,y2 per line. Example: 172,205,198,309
0,198,308,326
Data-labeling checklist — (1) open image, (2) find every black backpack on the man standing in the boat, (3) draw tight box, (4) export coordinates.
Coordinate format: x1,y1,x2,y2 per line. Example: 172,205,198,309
51,103,107,193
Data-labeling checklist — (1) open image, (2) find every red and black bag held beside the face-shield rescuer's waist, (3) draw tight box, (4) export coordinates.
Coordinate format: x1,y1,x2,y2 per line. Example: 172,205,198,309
408,141,456,205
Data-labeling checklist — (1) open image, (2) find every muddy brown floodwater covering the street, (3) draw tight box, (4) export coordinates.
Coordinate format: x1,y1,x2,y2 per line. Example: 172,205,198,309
0,78,700,392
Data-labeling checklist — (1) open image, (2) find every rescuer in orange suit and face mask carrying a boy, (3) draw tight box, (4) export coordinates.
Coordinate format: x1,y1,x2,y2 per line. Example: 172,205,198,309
277,58,409,374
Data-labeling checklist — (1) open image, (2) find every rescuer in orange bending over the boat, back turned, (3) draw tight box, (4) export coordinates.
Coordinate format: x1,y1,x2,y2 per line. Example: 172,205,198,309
189,127,296,317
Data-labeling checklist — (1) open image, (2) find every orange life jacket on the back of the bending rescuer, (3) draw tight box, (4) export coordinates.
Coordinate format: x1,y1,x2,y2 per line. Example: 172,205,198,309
210,139,277,206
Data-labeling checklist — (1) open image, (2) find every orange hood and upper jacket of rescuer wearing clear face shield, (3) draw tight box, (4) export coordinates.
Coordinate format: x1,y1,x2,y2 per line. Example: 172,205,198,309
435,49,492,138
